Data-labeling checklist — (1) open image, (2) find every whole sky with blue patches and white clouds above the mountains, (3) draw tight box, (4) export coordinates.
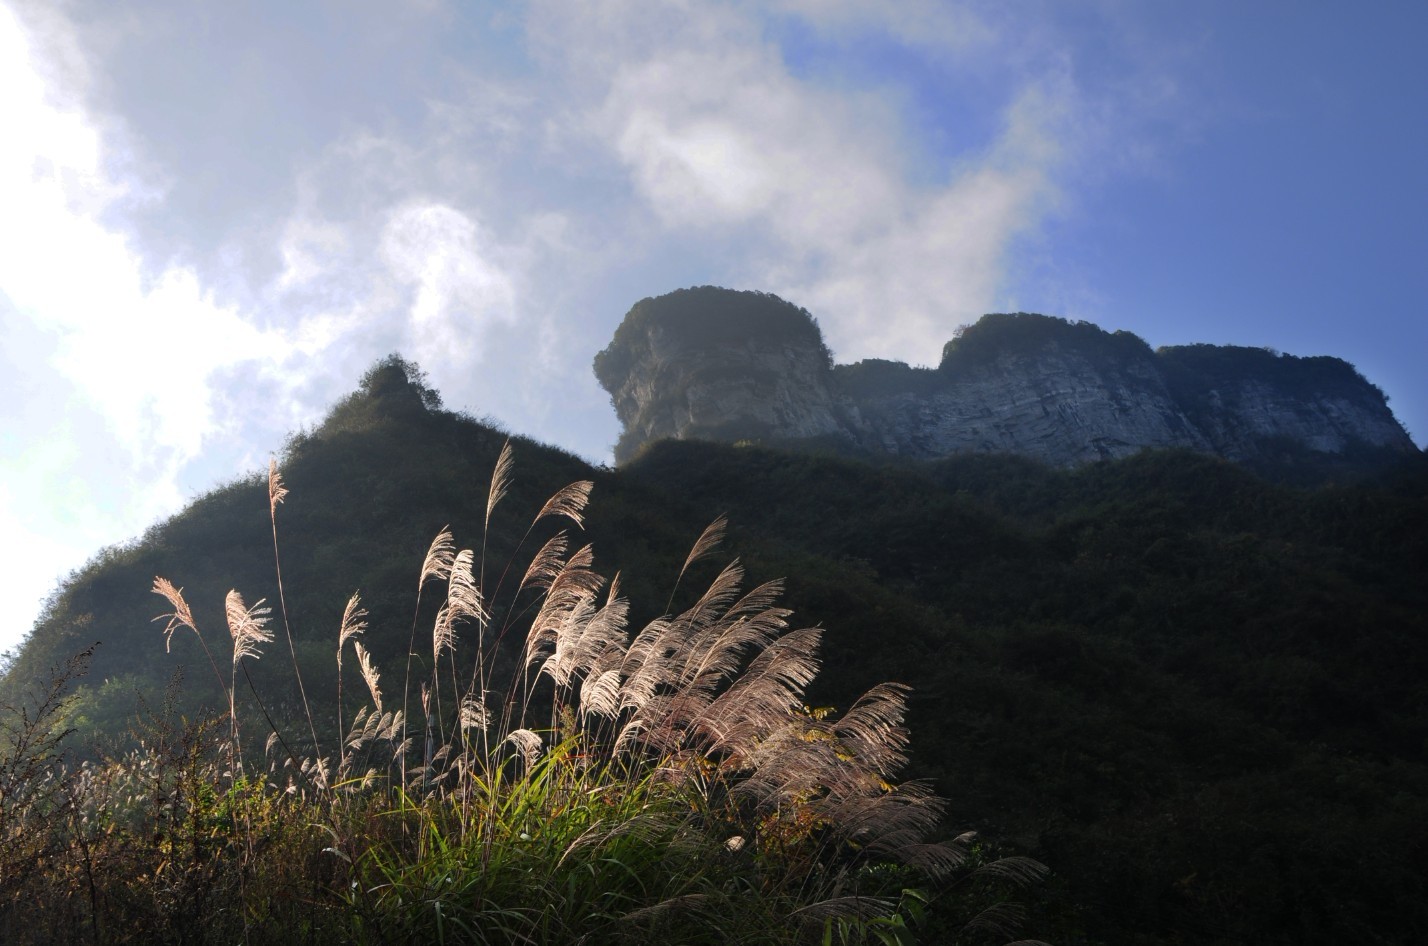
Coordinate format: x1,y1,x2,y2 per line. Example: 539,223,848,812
0,0,1428,649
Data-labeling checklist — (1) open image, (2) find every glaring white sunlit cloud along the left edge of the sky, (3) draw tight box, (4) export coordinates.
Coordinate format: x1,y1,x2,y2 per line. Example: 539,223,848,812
0,1,327,646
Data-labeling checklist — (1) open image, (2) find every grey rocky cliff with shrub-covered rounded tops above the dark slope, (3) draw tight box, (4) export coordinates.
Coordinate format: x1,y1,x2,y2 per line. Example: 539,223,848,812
595,287,1417,466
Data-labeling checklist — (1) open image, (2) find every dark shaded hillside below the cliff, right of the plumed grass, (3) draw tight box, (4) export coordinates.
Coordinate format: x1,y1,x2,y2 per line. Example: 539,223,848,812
627,443,1428,943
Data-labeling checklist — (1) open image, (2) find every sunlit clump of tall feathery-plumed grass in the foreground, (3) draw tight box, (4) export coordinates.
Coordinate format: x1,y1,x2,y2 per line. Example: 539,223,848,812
0,446,1044,945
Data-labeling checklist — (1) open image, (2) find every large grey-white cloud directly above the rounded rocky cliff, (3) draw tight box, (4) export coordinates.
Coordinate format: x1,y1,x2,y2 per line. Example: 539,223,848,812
551,1,1075,363
